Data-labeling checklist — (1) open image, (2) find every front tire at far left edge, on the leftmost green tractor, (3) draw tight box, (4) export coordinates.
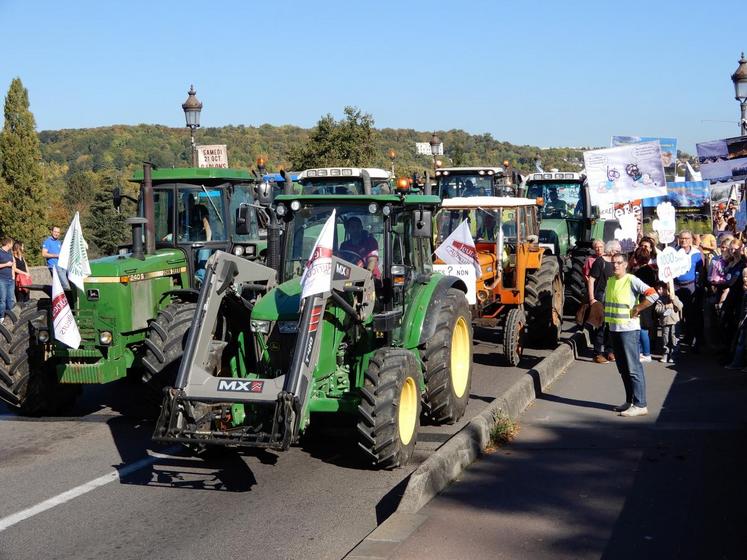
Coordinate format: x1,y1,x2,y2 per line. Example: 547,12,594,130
0,298,81,416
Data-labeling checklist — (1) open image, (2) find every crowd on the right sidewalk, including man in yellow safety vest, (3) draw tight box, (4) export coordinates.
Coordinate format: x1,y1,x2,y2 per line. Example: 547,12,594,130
582,231,747,416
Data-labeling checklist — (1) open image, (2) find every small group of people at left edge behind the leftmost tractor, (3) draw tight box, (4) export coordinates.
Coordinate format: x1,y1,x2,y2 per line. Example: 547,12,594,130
0,226,62,324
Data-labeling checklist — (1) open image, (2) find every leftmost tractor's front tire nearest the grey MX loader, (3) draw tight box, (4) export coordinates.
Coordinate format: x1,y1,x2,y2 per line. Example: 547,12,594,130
142,301,197,407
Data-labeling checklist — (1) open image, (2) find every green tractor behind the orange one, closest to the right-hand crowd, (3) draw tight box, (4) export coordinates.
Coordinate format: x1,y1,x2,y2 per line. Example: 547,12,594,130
523,171,620,304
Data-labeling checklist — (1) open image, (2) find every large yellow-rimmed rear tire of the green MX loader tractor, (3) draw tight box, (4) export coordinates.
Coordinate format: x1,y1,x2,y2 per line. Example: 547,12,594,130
421,288,472,424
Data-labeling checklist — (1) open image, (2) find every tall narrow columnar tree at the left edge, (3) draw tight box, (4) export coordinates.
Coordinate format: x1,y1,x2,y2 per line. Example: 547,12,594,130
0,78,49,264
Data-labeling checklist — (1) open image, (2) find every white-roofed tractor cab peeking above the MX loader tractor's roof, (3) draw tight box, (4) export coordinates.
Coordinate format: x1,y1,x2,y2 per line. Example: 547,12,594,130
298,167,393,195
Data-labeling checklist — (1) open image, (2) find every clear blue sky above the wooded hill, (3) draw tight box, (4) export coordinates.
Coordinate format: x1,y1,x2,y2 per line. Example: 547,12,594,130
0,0,747,153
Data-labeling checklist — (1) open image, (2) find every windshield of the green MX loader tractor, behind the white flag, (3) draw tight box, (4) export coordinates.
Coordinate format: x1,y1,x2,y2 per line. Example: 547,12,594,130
284,204,384,278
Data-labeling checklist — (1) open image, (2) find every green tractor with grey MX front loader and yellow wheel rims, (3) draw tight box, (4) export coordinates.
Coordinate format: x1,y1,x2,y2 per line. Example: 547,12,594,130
153,186,472,468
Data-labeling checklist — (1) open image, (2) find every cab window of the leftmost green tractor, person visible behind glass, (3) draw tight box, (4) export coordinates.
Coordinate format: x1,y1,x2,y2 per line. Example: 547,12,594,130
177,185,226,243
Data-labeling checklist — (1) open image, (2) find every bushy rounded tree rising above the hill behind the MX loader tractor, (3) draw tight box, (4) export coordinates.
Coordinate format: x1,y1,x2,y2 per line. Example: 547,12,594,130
290,107,377,169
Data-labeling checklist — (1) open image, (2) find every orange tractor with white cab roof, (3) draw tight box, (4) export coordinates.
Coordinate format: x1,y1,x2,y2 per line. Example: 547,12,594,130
436,196,563,366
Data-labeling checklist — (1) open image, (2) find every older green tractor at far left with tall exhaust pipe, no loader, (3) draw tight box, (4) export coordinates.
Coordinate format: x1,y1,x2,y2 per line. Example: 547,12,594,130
0,164,271,415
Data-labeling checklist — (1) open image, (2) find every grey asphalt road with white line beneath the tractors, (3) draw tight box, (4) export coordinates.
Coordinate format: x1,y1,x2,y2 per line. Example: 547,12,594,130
0,324,568,560
